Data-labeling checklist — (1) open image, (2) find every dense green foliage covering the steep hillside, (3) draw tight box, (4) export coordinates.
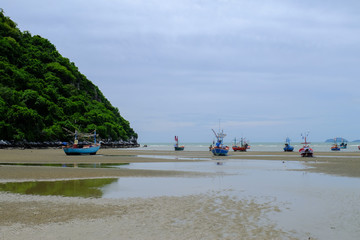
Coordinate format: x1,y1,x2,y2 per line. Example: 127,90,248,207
0,10,137,141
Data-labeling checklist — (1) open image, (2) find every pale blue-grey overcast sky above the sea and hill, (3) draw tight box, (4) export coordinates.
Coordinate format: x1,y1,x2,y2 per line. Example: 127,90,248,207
0,0,360,143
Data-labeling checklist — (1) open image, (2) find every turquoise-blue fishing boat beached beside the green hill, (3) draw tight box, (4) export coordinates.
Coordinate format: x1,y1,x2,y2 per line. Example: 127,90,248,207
63,130,101,155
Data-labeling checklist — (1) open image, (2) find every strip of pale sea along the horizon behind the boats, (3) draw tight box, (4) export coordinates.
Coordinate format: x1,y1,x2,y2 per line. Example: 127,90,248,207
138,142,360,152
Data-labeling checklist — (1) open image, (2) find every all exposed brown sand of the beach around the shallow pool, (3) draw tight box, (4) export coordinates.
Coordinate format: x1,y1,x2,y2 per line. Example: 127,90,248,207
0,149,360,240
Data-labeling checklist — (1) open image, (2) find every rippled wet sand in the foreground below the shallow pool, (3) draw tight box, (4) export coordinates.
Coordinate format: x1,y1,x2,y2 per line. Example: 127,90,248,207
0,193,296,240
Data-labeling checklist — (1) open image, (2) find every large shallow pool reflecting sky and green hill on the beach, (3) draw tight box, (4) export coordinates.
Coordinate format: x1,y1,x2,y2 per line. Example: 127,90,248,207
0,159,360,239
